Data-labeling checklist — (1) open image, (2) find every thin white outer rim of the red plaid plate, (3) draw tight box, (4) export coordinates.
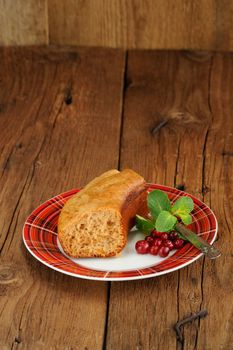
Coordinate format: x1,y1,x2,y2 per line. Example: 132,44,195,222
22,183,218,282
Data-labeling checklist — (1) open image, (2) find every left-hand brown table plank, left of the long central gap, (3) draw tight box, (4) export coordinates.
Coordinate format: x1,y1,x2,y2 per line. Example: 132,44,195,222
0,48,125,350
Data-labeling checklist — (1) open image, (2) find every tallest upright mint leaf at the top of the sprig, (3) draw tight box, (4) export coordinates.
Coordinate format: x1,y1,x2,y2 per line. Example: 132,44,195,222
147,190,171,219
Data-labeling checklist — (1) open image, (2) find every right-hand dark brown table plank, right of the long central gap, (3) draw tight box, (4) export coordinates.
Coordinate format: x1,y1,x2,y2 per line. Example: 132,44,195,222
107,51,233,350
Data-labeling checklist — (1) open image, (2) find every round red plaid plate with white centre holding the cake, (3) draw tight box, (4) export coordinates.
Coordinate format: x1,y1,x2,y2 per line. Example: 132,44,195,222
23,185,218,281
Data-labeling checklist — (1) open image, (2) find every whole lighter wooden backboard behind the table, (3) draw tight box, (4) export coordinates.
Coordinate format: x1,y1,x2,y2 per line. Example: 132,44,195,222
0,0,233,51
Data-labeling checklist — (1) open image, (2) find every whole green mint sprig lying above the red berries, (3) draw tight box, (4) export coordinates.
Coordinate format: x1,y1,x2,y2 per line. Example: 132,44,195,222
136,190,194,233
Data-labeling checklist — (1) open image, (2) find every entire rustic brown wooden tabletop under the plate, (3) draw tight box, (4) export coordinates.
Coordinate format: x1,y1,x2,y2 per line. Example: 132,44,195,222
0,48,233,350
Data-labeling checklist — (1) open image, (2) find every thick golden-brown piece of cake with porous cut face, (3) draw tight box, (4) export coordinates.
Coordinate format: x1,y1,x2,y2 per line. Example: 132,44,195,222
58,169,147,258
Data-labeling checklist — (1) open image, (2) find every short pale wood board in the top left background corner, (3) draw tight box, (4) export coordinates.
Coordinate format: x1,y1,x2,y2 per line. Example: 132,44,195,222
0,0,48,46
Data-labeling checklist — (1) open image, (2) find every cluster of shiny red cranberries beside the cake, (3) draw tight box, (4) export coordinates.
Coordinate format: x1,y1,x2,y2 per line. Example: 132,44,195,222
135,230,184,258
